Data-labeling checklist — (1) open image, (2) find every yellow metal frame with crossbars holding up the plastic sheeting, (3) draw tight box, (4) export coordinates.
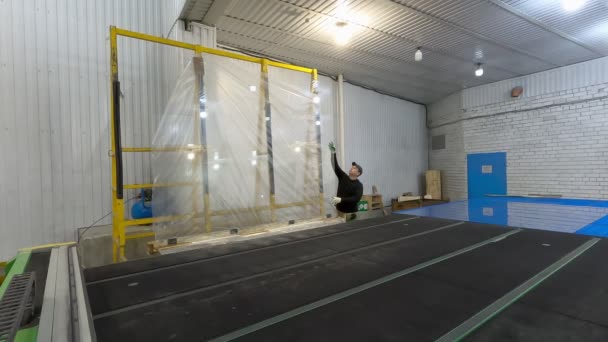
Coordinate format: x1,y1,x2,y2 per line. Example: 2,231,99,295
110,26,325,262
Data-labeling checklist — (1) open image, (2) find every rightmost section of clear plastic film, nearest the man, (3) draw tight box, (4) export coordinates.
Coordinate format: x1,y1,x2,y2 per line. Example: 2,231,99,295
268,67,322,221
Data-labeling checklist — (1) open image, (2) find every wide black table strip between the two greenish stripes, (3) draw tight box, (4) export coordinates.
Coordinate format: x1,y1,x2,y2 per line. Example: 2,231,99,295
239,230,589,341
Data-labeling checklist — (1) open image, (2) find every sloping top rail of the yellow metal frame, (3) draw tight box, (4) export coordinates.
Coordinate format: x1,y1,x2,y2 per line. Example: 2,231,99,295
116,28,314,74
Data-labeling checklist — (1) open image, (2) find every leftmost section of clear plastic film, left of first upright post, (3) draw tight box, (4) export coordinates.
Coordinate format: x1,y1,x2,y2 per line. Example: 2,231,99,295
152,63,204,238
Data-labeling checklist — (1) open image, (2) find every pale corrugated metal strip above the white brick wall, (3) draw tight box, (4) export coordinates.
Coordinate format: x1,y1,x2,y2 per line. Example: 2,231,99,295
462,57,608,108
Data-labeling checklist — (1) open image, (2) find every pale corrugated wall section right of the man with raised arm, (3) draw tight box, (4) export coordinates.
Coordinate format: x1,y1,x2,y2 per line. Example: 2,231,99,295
344,83,428,205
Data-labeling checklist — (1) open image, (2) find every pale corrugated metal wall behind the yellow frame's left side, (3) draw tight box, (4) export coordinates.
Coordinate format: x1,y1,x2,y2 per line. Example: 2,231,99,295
0,0,216,260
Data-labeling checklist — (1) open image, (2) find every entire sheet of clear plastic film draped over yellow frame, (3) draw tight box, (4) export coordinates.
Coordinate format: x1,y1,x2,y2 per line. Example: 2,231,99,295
152,54,322,239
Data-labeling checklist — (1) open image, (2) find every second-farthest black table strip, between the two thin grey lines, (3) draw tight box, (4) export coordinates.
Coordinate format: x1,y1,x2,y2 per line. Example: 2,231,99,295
87,218,455,315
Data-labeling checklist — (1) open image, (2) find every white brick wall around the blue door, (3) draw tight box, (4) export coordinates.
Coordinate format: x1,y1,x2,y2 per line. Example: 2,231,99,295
430,84,608,200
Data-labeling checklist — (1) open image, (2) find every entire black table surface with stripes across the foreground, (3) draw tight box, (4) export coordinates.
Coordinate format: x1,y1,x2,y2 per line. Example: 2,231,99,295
84,215,608,342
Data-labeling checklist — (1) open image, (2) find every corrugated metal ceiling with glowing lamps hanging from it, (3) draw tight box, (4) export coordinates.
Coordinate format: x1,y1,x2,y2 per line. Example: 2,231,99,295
138,0,608,101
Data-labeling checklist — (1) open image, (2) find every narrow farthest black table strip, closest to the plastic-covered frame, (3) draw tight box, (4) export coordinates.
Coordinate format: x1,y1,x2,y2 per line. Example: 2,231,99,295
84,215,414,283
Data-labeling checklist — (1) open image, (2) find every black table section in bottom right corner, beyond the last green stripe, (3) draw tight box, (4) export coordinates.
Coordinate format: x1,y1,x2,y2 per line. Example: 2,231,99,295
465,240,608,342
